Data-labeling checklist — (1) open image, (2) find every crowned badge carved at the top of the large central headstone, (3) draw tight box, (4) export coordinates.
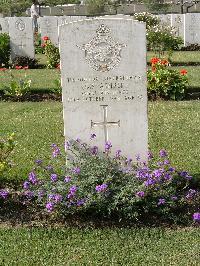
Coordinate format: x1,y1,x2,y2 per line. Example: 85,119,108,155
77,24,126,72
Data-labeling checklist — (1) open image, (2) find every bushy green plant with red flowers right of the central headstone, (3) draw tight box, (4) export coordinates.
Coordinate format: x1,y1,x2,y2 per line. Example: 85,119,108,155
147,57,188,100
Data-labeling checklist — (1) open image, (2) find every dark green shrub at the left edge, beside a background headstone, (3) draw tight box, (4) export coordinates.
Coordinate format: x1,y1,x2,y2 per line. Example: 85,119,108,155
0,33,10,67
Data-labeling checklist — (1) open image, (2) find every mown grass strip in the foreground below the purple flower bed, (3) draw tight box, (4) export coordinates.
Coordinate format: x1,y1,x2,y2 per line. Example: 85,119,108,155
0,228,200,266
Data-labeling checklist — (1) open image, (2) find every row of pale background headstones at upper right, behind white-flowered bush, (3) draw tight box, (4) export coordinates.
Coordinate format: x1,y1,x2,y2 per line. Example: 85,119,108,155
158,13,200,46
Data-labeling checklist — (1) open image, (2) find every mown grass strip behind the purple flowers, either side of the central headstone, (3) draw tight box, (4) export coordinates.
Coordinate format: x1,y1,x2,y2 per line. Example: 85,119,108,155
0,101,200,185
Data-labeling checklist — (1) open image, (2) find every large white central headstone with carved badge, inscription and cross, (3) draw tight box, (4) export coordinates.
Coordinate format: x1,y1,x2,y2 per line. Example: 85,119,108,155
59,18,148,158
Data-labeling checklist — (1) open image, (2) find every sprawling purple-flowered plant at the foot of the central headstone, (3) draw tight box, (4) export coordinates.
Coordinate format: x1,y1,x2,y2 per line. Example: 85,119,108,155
23,134,199,222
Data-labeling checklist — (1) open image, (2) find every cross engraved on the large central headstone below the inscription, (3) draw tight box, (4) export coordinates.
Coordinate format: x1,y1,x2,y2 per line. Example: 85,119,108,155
91,105,120,142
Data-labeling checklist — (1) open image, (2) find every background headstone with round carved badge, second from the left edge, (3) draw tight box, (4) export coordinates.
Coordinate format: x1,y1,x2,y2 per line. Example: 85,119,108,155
9,17,35,59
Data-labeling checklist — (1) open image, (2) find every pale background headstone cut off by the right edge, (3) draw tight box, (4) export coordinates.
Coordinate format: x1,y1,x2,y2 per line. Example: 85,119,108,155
185,13,200,46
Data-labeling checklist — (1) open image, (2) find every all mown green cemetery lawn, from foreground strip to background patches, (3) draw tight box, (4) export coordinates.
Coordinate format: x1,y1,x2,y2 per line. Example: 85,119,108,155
0,52,200,266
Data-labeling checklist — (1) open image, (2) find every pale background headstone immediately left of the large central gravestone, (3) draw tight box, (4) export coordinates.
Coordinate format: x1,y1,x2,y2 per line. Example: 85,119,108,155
39,16,58,46
